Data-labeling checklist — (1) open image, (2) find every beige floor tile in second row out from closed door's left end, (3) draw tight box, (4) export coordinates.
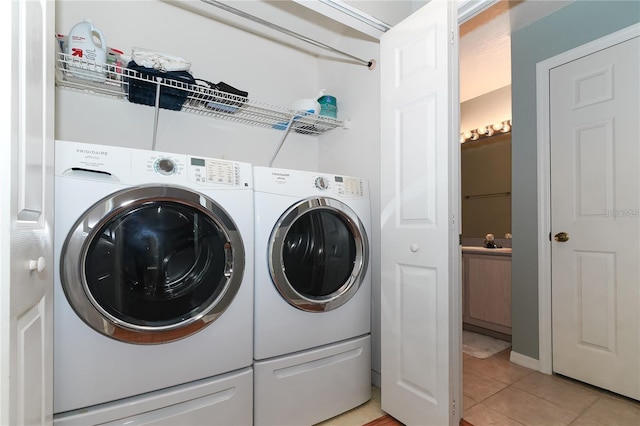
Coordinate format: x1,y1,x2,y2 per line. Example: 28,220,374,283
483,386,578,426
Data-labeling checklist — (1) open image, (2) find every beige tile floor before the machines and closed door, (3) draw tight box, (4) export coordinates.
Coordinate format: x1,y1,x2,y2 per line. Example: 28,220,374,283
320,348,640,426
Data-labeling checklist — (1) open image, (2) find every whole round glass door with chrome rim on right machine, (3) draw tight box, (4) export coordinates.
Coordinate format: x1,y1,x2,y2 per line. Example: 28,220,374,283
269,198,369,312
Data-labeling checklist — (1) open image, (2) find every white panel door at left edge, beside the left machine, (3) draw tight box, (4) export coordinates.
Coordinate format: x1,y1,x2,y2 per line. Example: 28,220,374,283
0,0,55,425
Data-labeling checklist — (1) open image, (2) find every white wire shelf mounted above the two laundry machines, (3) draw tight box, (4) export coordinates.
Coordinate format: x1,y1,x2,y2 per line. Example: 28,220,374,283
56,52,345,135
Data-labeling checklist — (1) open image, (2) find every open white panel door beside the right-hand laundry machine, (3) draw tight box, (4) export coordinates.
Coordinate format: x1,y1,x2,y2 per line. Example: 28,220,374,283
380,0,462,425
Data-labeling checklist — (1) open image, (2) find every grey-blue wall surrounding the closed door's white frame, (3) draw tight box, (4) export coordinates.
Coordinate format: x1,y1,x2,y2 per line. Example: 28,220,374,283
511,0,640,359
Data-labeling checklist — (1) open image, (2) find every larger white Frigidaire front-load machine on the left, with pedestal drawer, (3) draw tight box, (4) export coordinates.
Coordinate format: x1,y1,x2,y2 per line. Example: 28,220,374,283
54,141,254,425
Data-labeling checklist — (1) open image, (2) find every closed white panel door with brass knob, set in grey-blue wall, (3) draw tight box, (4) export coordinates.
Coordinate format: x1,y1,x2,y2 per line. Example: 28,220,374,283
550,37,640,399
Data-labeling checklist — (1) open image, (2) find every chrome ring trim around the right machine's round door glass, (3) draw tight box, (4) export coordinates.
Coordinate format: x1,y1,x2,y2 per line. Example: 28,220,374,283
268,197,369,312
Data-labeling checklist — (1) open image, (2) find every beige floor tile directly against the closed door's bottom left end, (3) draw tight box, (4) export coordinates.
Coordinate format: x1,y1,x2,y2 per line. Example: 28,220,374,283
513,371,602,414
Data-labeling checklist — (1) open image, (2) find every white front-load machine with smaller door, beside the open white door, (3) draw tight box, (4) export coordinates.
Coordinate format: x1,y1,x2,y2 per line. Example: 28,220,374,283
254,167,371,425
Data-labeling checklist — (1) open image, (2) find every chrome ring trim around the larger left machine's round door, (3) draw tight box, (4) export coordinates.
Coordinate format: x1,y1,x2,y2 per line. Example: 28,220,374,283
60,185,245,344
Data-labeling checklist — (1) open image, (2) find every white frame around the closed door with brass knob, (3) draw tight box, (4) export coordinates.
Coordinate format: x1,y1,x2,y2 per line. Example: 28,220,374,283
536,23,640,374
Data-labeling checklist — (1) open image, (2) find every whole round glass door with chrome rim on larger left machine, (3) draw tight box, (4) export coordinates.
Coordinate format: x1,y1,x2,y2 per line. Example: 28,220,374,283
60,185,244,344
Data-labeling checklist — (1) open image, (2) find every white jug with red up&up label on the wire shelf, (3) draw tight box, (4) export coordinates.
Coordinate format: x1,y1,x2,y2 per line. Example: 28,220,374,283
65,19,107,81
